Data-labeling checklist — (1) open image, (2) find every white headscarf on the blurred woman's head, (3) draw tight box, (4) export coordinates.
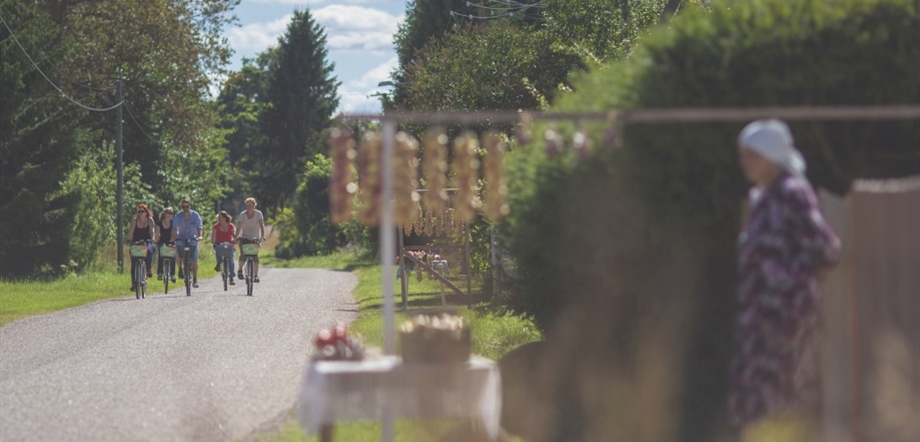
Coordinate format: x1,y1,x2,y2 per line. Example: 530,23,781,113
738,119,805,176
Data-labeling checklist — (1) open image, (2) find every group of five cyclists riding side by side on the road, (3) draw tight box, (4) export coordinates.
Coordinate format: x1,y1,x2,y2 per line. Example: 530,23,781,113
127,197,265,291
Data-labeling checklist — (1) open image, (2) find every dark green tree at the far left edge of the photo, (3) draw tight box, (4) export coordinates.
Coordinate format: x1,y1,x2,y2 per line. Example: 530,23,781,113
0,2,86,276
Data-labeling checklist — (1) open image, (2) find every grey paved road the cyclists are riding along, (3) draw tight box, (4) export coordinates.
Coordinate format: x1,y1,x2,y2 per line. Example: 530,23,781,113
0,269,357,442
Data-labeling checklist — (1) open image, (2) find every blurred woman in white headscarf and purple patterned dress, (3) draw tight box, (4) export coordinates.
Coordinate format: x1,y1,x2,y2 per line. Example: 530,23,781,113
729,120,840,442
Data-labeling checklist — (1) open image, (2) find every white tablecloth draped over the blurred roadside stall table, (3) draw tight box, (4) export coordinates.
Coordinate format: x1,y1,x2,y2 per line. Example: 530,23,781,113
297,356,501,439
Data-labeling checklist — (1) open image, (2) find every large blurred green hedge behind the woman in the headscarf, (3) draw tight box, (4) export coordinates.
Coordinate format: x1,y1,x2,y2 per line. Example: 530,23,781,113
502,0,920,440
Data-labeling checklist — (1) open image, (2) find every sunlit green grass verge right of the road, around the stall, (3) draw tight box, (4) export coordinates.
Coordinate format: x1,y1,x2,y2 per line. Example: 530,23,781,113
257,253,541,442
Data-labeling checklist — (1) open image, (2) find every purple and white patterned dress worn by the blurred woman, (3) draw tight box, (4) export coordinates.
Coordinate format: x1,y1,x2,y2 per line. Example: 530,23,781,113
728,174,840,425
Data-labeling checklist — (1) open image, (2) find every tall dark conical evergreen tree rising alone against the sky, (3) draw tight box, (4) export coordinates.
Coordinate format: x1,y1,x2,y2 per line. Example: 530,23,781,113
256,10,341,212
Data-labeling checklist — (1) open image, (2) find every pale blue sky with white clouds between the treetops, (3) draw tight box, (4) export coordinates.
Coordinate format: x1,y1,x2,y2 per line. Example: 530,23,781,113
225,0,406,113
